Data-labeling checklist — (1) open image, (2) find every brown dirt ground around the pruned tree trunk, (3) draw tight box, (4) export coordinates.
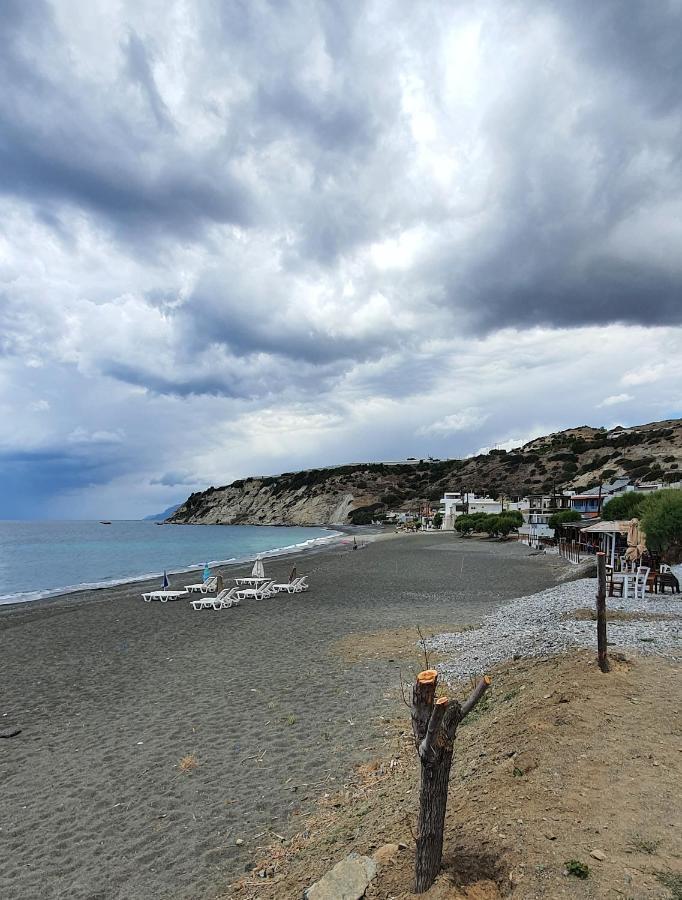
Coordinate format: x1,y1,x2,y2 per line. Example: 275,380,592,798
224,629,682,900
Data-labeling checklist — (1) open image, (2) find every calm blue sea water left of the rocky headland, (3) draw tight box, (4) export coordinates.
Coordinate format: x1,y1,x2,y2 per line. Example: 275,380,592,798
0,521,335,604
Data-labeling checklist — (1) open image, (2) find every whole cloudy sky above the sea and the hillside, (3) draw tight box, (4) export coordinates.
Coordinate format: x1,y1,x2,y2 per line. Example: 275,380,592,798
0,0,682,518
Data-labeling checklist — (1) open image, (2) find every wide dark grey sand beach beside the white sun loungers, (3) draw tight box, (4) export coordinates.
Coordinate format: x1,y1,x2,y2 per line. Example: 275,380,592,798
0,534,556,900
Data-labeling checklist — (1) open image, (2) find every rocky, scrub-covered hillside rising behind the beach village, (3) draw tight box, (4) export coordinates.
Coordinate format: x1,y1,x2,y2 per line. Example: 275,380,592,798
168,419,682,525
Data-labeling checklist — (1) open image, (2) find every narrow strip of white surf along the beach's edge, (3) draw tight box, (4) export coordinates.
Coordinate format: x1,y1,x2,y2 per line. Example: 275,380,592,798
0,525,390,615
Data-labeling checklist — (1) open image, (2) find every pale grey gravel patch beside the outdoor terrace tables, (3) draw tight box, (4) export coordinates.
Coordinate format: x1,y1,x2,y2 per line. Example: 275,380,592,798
429,573,682,681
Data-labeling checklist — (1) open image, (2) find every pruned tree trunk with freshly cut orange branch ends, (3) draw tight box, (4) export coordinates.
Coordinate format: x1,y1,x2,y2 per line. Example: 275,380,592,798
412,669,491,894
